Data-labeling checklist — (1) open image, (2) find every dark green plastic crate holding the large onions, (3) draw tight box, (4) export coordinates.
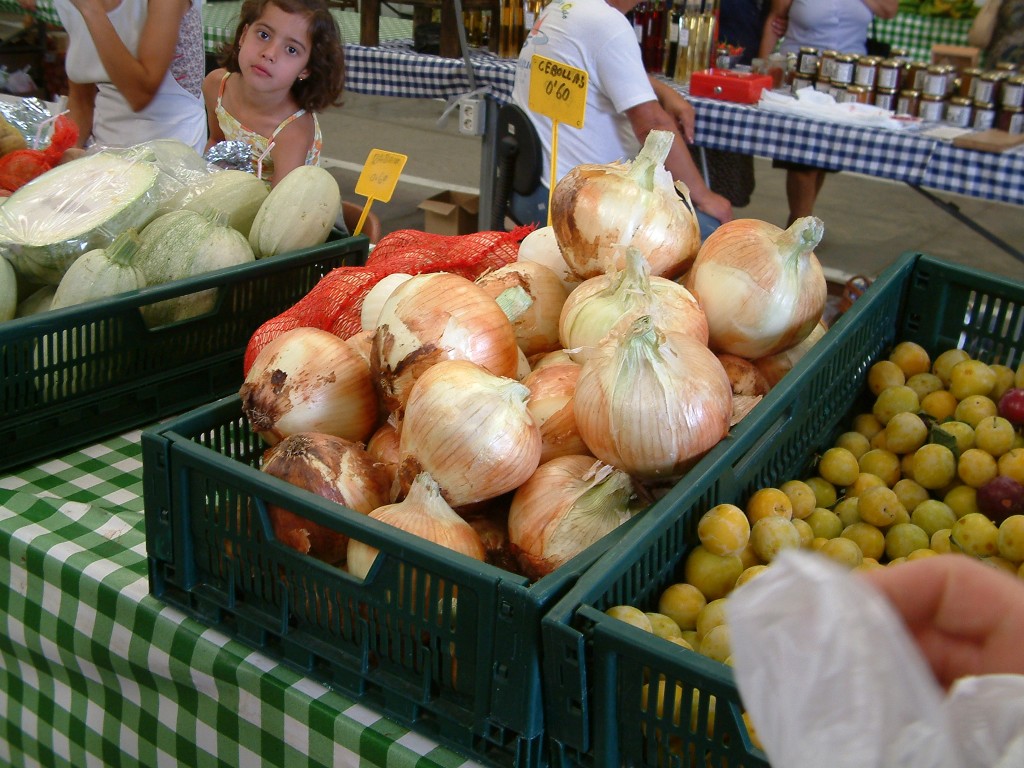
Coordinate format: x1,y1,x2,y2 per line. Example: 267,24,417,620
142,395,636,768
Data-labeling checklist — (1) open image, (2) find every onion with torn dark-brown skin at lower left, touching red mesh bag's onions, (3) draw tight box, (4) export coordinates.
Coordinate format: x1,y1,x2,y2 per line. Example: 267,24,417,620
371,272,519,412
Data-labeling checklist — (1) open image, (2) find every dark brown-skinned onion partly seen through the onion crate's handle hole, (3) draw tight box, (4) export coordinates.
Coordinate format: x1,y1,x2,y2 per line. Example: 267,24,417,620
261,432,390,563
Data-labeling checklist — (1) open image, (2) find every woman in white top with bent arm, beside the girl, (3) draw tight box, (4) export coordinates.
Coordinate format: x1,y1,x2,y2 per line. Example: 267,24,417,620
54,0,207,153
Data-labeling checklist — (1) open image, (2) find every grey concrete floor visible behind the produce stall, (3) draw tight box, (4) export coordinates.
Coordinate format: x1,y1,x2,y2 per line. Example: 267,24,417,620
322,93,1024,281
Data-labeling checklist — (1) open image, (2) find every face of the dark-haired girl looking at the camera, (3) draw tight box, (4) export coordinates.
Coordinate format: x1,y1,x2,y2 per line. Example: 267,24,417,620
239,3,312,90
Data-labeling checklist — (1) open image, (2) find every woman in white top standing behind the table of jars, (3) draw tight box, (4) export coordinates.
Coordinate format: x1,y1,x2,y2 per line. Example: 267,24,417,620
761,0,899,224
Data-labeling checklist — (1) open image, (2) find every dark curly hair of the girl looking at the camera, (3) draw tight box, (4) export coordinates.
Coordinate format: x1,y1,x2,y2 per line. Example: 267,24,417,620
220,0,345,112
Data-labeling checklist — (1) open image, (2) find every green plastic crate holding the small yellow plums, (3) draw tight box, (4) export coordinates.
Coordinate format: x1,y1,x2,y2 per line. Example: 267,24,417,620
542,253,1024,768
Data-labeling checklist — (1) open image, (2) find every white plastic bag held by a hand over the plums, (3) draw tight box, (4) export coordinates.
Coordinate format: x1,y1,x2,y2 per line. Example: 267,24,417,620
727,551,1024,768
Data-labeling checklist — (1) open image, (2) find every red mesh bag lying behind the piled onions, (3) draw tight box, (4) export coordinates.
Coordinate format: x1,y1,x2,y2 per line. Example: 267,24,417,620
243,225,534,374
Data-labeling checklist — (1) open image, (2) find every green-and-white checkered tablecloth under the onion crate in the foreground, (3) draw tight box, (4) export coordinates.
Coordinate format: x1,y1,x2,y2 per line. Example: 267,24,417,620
0,431,475,768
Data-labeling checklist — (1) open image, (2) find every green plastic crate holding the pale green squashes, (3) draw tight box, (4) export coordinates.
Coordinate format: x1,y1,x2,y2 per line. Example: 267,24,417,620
0,231,370,470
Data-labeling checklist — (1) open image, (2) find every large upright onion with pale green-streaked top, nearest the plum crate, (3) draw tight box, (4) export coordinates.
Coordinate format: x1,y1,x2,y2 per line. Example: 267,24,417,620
575,315,732,479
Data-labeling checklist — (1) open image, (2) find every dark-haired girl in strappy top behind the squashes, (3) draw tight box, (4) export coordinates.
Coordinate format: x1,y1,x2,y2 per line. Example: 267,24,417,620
203,0,345,186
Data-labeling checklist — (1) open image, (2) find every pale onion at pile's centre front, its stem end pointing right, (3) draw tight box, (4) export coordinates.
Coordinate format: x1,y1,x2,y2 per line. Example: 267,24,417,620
398,360,541,507
